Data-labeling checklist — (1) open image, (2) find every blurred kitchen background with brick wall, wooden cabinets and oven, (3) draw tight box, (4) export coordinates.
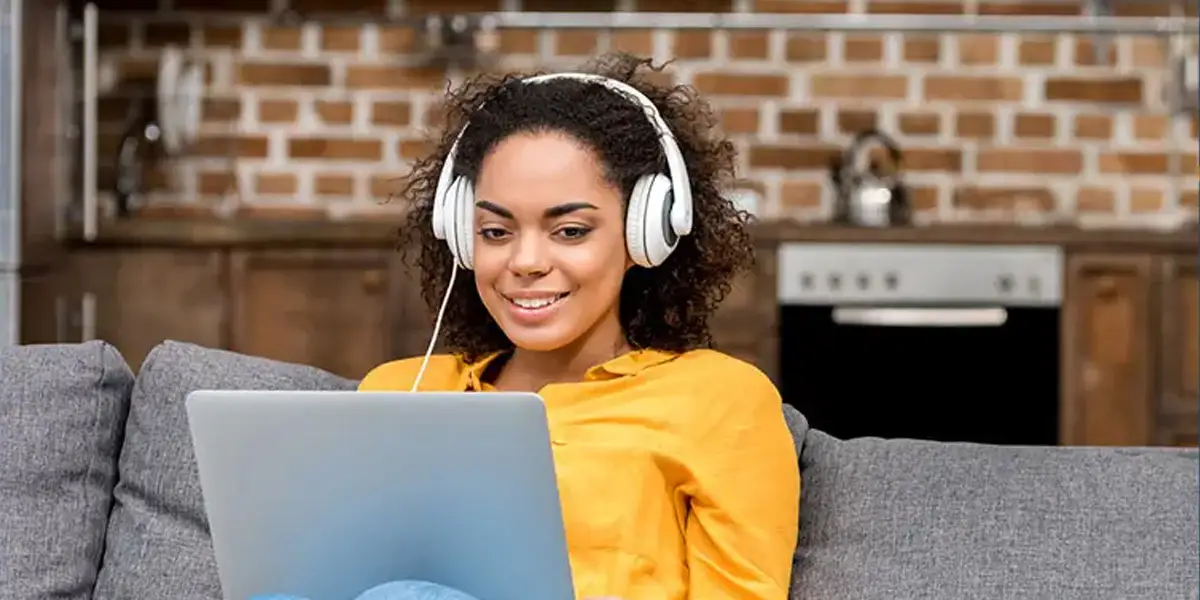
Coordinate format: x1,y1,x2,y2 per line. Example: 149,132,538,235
0,0,1200,446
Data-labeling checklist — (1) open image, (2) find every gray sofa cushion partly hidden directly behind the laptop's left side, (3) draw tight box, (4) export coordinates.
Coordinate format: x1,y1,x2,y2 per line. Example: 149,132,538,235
96,342,356,600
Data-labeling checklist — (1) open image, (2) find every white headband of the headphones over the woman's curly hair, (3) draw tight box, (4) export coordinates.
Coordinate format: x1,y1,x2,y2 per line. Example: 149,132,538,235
433,72,692,239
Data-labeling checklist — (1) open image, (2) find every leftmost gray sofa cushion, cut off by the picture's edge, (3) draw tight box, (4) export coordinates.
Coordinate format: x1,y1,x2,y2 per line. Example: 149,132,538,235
0,342,133,600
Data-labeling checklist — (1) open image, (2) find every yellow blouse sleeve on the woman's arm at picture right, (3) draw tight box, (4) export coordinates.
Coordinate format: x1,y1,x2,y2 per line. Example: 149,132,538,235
685,364,800,600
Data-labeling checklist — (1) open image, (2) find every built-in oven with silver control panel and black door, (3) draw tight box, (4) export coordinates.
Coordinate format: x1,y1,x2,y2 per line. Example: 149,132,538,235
778,244,1063,445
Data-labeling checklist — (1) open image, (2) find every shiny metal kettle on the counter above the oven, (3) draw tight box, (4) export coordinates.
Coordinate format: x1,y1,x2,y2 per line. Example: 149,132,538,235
829,130,912,227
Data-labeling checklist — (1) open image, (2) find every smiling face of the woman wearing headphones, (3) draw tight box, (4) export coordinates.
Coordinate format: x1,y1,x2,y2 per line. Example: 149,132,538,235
474,132,631,352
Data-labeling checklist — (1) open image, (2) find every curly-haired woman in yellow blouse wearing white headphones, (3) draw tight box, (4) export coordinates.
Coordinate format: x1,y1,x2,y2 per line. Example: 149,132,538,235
260,55,799,600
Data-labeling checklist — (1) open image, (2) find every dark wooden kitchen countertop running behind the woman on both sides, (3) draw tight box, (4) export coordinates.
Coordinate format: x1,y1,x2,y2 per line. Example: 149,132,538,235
70,218,1200,252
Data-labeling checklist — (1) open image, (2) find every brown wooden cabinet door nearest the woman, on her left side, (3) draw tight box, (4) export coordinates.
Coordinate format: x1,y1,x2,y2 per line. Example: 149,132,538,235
229,250,391,378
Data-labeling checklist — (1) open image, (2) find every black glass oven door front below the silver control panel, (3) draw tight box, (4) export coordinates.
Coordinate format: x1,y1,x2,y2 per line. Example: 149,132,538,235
780,305,1060,445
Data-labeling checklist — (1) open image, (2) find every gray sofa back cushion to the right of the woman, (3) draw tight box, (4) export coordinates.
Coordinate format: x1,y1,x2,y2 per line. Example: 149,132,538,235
797,430,1200,600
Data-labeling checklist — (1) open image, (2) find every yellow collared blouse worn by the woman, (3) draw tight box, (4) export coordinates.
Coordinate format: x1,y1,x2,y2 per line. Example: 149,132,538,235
359,350,800,600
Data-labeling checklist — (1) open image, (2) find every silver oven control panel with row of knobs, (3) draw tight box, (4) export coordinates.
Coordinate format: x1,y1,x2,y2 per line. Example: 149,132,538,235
778,242,1063,306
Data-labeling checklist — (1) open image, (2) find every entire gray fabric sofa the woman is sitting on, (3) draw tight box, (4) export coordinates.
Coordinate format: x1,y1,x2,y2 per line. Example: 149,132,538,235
0,342,1200,600
